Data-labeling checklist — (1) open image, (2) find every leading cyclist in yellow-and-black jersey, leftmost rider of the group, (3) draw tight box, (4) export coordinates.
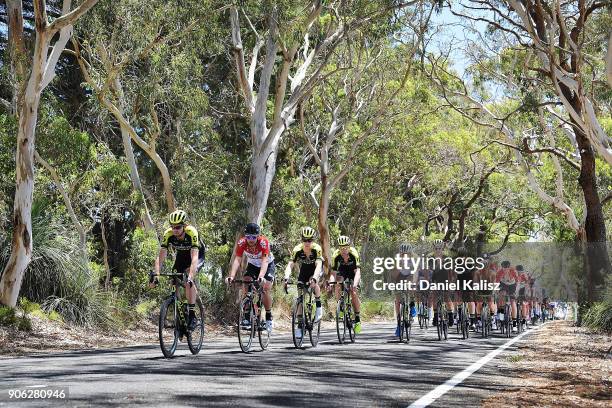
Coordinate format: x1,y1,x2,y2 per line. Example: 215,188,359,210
149,210,204,330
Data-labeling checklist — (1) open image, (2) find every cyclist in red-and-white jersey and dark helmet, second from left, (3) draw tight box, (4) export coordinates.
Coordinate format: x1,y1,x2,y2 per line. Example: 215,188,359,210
226,223,276,332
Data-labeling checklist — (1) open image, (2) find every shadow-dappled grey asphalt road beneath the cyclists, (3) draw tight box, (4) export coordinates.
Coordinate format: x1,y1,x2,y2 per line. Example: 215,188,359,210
0,322,530,408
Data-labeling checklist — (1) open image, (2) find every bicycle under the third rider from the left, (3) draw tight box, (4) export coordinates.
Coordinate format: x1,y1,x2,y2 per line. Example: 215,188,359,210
285,282,321,348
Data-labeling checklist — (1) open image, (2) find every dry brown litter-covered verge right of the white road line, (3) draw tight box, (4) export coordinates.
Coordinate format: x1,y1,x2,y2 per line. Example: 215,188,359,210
482,321,612,408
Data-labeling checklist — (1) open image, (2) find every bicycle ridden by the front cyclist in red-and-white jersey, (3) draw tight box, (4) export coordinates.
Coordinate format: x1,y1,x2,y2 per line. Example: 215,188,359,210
232,279,270,353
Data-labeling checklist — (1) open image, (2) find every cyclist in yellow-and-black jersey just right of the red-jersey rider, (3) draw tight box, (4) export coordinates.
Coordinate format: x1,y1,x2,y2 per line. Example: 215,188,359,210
284,227,323,337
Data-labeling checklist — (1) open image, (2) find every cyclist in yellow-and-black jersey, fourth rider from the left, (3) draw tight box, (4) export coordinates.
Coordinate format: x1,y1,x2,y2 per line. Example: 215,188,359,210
329,235,361,334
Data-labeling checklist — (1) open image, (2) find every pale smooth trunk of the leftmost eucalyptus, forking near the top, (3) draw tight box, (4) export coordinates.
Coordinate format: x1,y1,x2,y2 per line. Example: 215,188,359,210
0,0,98,307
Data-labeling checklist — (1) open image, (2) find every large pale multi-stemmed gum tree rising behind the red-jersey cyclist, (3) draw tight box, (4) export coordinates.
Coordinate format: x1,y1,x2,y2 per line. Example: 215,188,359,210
230,0,417,223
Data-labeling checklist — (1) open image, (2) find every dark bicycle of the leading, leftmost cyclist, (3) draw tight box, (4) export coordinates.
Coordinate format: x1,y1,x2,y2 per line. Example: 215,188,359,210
152,273,204,358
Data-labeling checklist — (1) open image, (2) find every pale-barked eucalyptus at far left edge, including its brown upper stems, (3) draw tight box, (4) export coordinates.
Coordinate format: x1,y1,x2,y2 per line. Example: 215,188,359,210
0,0,98,307
